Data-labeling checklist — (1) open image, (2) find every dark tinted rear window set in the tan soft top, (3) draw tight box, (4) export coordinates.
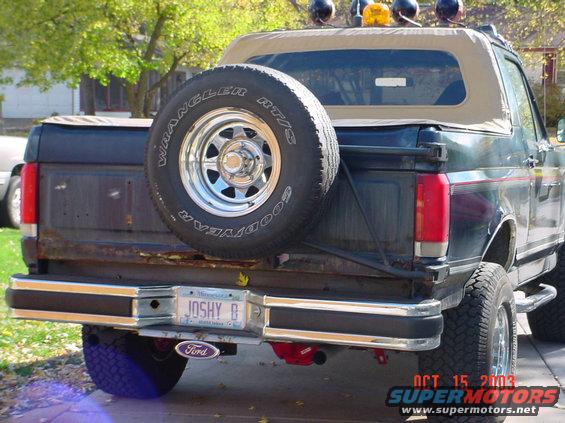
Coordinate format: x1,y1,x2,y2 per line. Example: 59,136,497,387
247,50,467,106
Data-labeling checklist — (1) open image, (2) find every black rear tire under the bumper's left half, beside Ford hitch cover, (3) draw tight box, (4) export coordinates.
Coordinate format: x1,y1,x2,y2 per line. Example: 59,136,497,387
82,325,187,399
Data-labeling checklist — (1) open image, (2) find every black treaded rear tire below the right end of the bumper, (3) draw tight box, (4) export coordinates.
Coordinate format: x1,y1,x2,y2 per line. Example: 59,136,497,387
418,263,517,422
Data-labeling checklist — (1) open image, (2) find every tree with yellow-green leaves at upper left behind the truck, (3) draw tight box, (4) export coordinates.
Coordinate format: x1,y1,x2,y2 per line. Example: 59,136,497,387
0,0,302,117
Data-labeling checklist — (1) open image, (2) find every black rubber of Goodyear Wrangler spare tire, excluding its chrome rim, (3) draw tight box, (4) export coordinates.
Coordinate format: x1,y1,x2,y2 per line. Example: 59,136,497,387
145,65,339,259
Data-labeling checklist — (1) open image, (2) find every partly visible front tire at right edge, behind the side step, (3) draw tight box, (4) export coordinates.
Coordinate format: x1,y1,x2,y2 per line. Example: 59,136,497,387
528,249,565,342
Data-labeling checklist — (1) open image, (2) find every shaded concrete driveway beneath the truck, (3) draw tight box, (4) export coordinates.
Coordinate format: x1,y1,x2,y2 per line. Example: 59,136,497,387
8,316,565,423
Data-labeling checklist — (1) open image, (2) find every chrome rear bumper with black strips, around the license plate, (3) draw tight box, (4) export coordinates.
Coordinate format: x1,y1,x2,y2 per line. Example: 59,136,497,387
6,275,443,351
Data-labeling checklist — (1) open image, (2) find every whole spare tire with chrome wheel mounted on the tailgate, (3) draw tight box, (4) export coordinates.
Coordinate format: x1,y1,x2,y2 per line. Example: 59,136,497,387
145,65,339,259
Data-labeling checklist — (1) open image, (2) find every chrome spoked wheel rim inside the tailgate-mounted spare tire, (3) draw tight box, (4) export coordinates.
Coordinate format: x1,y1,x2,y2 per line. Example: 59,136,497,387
179,108,281,217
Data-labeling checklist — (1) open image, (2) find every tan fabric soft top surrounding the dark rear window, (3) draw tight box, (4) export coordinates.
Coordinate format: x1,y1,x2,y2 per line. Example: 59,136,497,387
220,28,511,134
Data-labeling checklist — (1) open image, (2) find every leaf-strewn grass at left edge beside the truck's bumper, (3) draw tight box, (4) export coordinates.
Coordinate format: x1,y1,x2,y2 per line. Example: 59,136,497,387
0,228,93,420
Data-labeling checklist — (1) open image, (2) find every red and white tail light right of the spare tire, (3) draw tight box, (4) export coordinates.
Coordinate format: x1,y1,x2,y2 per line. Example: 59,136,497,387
414,174,449,257
